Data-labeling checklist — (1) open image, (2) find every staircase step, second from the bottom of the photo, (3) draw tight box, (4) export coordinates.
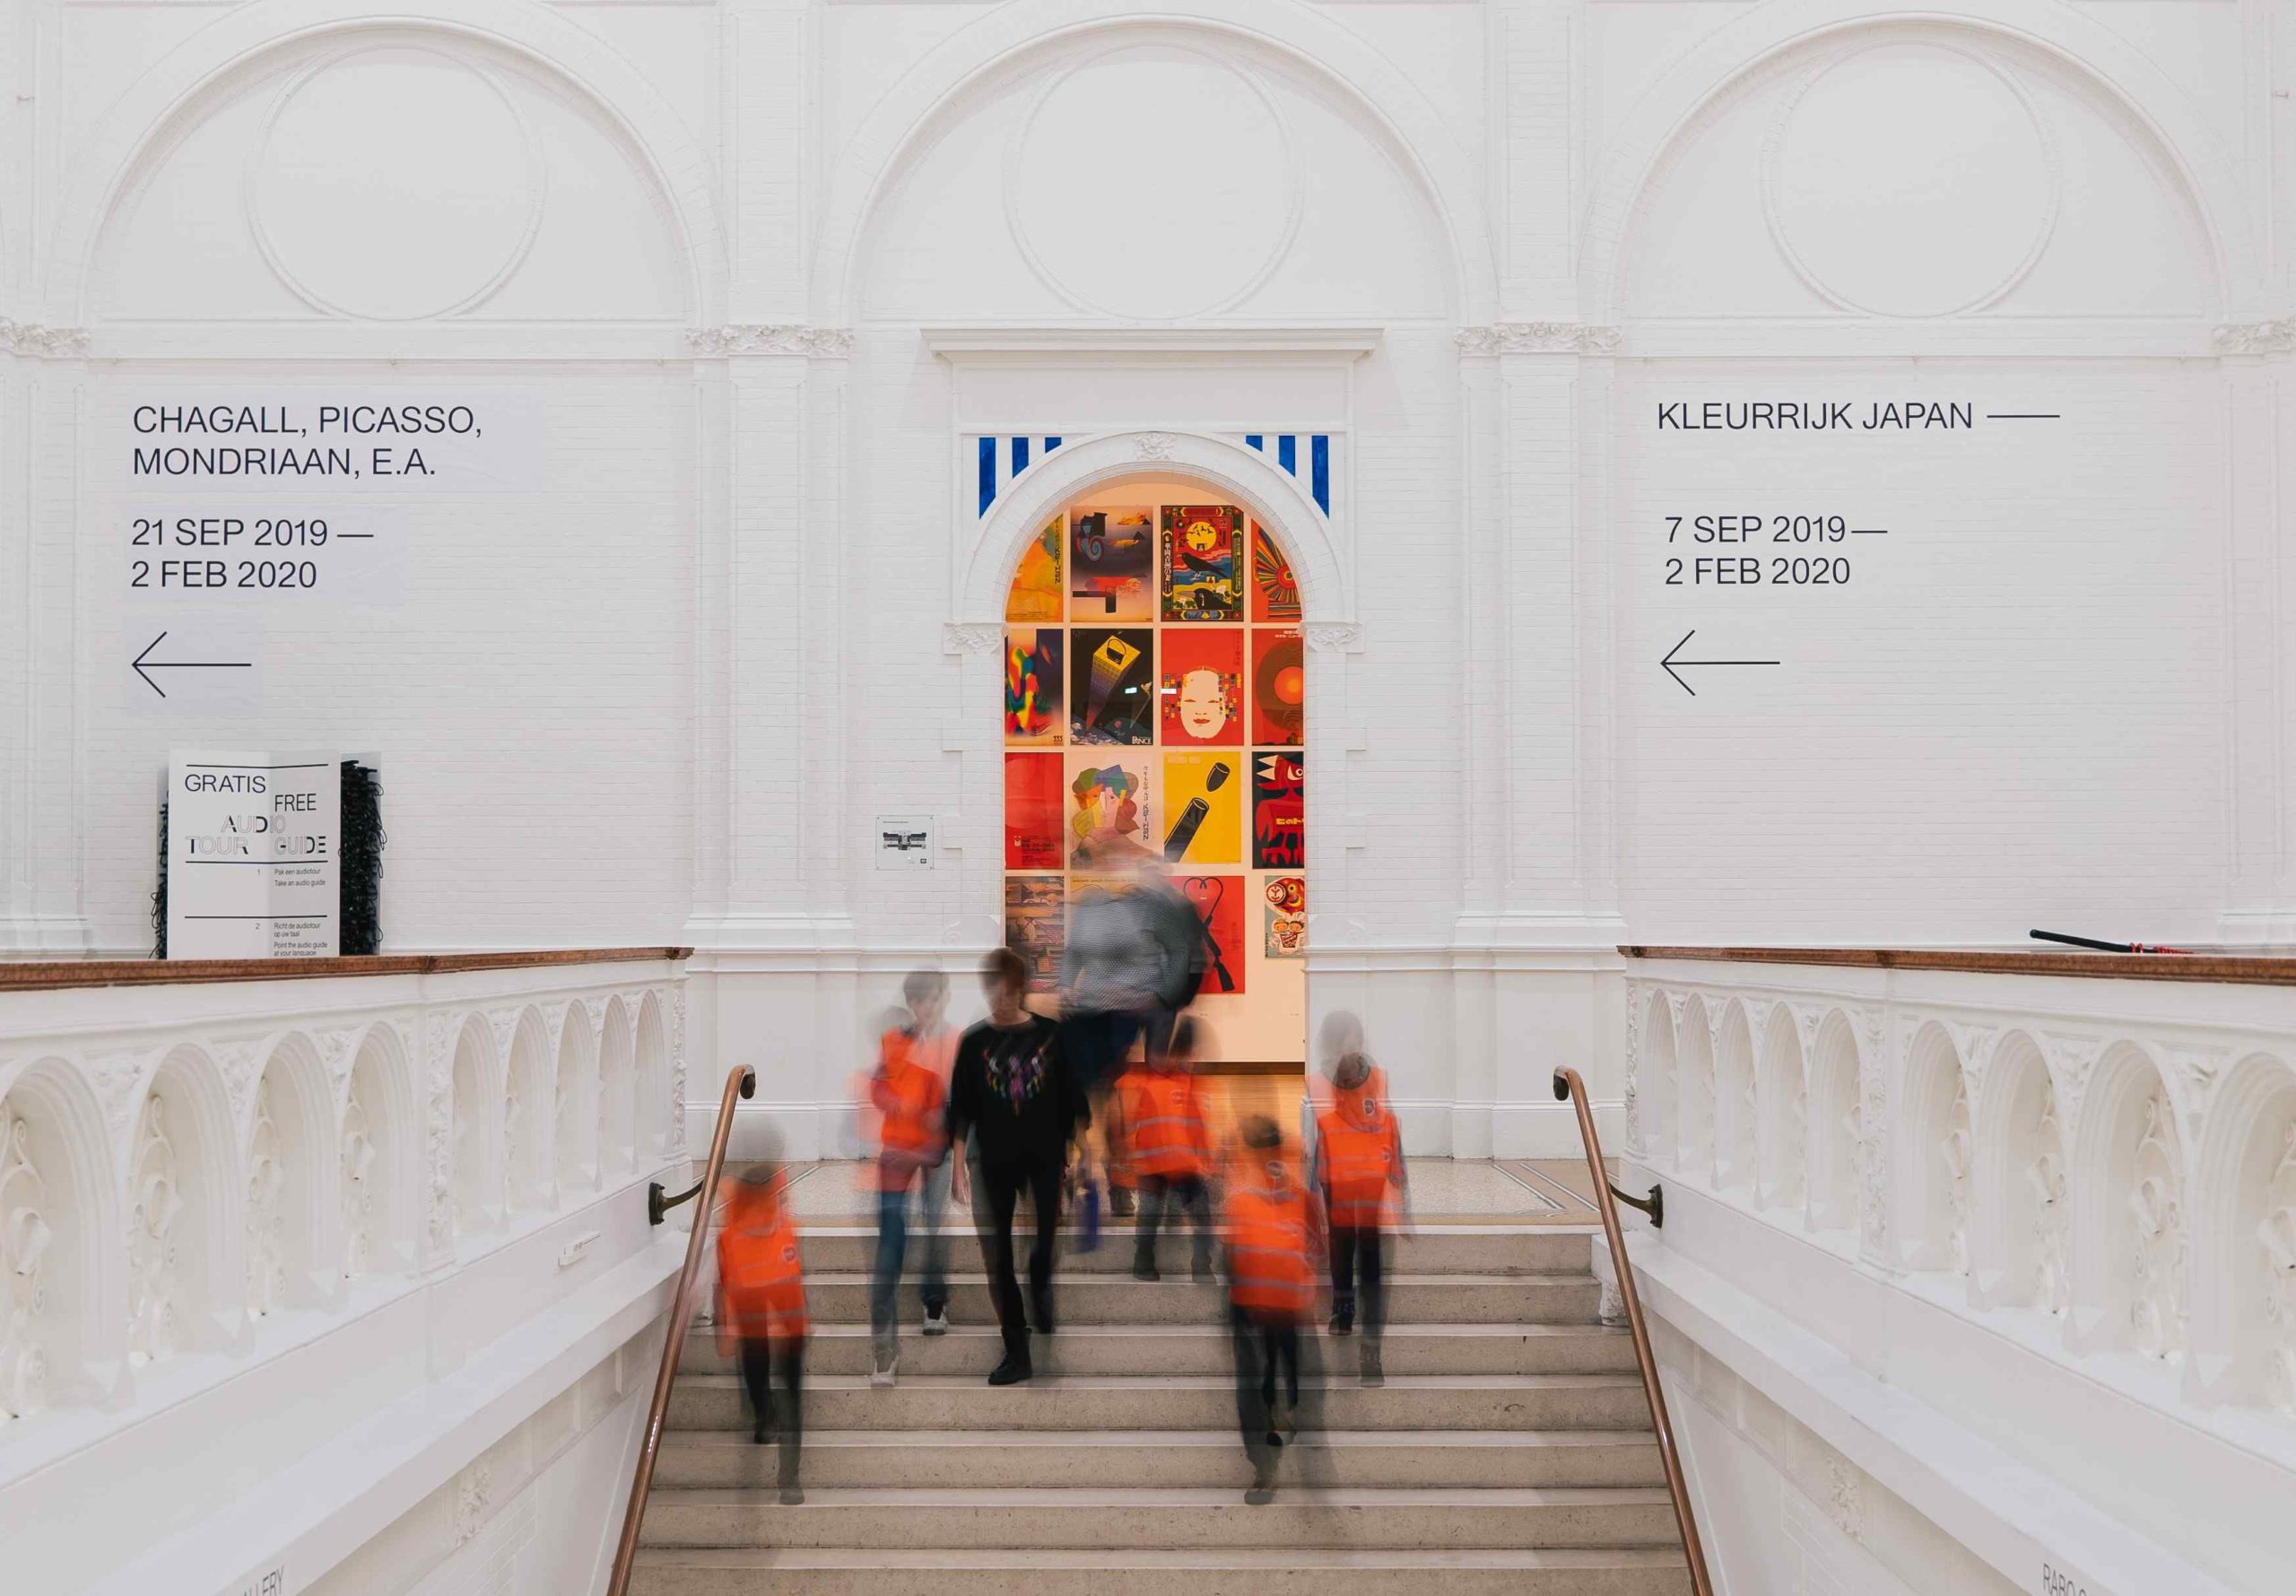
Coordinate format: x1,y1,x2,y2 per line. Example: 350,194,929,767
643,1488,1674,1550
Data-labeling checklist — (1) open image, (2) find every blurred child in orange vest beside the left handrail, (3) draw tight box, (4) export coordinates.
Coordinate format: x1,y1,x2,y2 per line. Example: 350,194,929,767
717,1162,811,1505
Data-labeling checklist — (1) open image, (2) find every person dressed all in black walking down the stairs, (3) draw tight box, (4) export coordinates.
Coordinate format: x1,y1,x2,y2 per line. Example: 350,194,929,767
948,949,1091,1384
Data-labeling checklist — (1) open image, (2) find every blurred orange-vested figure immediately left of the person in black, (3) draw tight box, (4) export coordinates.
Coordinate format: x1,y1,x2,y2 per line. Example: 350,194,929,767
864,969,958,1384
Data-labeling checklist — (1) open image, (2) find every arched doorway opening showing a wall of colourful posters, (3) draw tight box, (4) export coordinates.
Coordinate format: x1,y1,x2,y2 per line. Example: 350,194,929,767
1001,473,1311,1072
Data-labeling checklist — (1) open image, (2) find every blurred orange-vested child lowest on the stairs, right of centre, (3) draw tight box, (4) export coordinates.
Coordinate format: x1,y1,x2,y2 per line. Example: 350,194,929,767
1226,1114,1316,1506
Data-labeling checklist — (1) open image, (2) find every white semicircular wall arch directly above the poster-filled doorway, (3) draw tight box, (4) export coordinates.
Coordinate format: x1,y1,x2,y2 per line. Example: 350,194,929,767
854,23,1456,324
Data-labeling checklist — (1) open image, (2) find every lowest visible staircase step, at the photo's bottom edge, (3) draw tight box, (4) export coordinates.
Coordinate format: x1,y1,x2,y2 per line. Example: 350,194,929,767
631,1552,1690,1596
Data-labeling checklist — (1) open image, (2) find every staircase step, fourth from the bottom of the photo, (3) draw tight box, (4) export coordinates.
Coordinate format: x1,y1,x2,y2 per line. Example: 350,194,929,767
668,1377,1651,1431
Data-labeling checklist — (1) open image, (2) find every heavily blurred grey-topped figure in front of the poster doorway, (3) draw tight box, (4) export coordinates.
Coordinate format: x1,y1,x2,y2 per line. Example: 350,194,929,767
1061,856,1203,1212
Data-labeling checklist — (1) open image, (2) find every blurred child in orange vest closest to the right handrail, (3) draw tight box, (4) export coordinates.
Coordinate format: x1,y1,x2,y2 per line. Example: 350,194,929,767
1316,1052,1407,1384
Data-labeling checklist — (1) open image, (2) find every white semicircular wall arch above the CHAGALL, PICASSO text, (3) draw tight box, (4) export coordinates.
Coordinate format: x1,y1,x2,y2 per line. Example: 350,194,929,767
91,25,693,324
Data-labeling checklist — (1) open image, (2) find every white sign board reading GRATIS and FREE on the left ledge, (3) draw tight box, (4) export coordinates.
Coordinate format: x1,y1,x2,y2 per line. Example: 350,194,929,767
168,750,342,958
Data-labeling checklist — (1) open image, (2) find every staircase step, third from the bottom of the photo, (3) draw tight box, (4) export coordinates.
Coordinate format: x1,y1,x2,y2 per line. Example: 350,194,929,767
655,1424,1667,1490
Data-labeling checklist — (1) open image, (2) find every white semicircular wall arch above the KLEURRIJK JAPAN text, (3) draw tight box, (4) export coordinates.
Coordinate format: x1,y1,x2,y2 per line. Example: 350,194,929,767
1605,21,2218,324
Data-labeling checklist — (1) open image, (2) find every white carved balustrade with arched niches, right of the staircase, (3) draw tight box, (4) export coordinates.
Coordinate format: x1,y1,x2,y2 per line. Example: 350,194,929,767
1625,958,2296,1417
